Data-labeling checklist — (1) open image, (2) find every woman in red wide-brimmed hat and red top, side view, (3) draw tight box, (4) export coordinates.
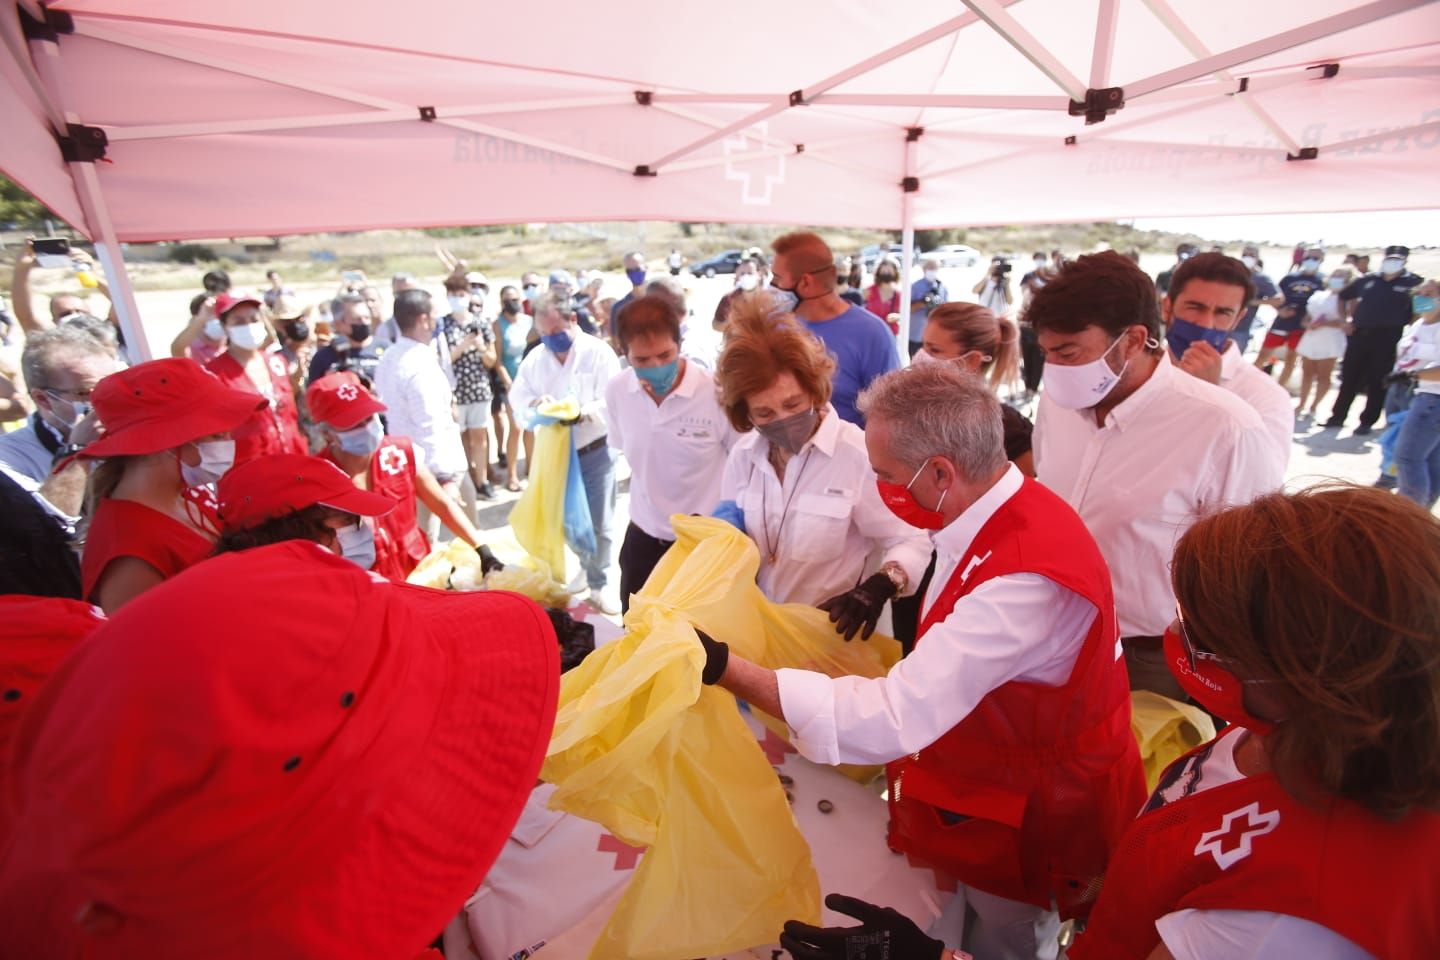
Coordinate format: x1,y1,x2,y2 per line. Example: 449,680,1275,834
78,358,265,613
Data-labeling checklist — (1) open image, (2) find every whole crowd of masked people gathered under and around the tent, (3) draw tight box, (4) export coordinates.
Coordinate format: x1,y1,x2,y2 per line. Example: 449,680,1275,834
0,232,1440,960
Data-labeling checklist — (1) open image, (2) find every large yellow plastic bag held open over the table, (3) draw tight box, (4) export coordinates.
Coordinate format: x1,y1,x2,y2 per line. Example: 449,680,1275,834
541,517,899,960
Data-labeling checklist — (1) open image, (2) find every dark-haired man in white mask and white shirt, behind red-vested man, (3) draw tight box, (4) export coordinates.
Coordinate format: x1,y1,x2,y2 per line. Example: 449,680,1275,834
1027,252,1284,701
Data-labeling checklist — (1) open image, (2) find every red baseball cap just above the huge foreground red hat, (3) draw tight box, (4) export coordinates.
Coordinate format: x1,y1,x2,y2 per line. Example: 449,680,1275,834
215,453,396,533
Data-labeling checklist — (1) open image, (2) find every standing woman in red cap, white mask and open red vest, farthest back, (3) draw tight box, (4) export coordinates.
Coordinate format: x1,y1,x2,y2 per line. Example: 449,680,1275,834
204,294,310,463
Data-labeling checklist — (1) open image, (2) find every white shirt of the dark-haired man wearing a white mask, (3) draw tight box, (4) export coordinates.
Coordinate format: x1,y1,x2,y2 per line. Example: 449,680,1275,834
1034,357,1284,636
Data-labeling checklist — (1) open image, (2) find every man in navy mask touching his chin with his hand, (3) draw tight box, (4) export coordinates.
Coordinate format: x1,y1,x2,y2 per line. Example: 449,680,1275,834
1161,253,1295,476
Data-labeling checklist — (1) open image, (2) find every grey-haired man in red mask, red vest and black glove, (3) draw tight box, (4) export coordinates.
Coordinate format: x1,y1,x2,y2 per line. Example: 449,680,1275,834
700,364,1145,959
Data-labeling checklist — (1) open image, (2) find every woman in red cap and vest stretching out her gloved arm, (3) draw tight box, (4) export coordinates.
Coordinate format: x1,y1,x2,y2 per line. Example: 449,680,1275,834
305,371,501,580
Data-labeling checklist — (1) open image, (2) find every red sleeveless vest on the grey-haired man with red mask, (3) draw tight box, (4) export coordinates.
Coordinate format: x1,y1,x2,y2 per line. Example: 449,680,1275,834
887,479,1145,918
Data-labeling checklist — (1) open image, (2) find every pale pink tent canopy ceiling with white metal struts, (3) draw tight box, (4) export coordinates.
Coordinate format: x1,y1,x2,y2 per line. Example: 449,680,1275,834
0,0,1440,240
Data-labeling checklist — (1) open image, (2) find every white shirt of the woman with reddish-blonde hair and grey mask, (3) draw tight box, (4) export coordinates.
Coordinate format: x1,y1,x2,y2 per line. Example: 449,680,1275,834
720,404,930,606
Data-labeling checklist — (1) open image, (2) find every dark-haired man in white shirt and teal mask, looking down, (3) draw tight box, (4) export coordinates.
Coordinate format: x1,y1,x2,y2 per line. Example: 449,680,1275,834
605,295,739,612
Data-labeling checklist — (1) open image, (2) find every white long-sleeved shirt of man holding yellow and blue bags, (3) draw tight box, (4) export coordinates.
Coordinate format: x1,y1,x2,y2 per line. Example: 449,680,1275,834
510,327,621,449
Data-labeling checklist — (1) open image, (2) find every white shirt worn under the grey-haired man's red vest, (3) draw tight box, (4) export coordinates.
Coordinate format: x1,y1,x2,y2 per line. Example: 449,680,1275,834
776,463,1100,763
